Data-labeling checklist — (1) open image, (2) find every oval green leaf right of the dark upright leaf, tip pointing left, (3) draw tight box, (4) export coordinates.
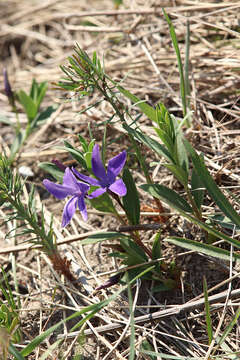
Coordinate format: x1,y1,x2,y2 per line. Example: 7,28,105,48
140,184,192,213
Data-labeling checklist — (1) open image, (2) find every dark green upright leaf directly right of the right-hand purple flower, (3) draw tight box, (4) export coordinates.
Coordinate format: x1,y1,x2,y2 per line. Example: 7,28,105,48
122,168,140,225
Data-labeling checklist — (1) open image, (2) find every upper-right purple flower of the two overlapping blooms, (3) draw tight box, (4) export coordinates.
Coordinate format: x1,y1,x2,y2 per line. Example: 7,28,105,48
72,144,127,199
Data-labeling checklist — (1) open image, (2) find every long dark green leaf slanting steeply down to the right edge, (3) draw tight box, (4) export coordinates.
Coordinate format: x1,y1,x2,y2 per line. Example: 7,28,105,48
184,140,240,226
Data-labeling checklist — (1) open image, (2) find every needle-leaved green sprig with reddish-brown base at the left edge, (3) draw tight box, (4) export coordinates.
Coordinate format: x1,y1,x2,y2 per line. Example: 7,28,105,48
0,154,75,281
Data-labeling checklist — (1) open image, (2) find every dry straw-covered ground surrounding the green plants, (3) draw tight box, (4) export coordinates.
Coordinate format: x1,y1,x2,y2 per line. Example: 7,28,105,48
0,0,240,359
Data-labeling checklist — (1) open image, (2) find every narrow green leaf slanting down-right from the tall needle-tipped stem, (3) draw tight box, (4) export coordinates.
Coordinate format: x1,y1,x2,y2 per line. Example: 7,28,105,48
123,124,174,163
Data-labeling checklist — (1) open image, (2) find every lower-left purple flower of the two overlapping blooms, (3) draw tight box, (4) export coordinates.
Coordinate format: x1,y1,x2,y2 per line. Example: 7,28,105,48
43,168,90,227
